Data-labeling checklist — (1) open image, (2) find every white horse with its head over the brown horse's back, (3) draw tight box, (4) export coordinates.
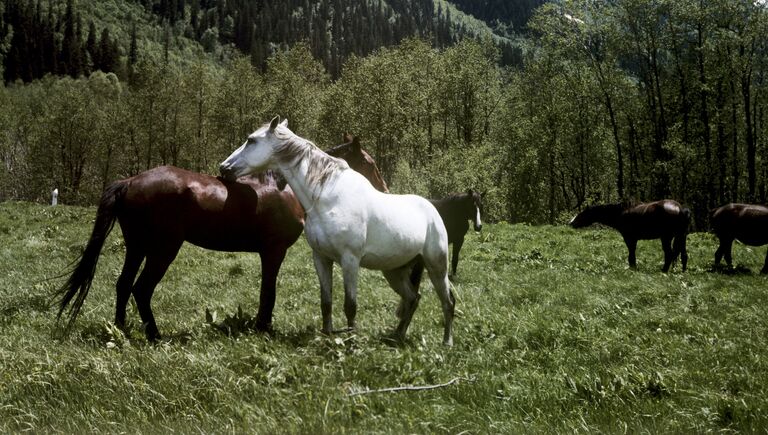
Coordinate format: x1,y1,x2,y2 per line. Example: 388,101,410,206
219,117,455,346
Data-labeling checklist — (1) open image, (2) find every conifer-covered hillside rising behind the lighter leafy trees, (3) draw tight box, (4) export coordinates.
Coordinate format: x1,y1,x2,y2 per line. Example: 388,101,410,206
0,0,537,83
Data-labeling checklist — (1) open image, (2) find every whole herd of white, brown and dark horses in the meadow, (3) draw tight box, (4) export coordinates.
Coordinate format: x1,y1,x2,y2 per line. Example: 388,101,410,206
56,117,768,346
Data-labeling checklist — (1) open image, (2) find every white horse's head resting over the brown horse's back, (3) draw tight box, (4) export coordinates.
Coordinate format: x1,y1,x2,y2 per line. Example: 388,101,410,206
219,116,290,180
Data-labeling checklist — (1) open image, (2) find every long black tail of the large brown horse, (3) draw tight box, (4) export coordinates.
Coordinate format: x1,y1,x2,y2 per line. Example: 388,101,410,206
54,181,128,330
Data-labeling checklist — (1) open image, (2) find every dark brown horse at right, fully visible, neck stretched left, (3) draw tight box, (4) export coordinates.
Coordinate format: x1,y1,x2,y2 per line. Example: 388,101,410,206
570,199,691,272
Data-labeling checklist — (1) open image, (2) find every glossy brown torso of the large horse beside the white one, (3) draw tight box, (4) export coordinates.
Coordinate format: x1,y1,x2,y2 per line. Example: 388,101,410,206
118,166,304,252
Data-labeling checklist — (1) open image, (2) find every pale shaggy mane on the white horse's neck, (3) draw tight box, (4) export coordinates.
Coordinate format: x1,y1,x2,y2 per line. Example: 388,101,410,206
274,125,349,188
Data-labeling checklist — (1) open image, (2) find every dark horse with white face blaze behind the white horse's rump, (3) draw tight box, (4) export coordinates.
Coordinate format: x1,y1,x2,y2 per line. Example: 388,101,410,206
429,189,483,275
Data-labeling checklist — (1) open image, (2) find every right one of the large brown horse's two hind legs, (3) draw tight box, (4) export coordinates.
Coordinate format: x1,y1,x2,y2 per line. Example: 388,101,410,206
133,241,183,341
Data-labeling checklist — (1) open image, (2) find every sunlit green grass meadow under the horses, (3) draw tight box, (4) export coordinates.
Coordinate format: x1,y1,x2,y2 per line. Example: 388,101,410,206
0,203,768,433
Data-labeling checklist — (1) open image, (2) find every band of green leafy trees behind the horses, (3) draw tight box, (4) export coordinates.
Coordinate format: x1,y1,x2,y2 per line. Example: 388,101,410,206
0,0,768,230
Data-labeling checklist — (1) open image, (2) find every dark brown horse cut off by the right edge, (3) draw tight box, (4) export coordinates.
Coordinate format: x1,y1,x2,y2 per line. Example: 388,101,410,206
710,204,768,273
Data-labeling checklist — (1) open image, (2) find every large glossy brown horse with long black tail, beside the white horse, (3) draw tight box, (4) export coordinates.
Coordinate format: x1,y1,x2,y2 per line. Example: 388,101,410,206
57,141,388,341
